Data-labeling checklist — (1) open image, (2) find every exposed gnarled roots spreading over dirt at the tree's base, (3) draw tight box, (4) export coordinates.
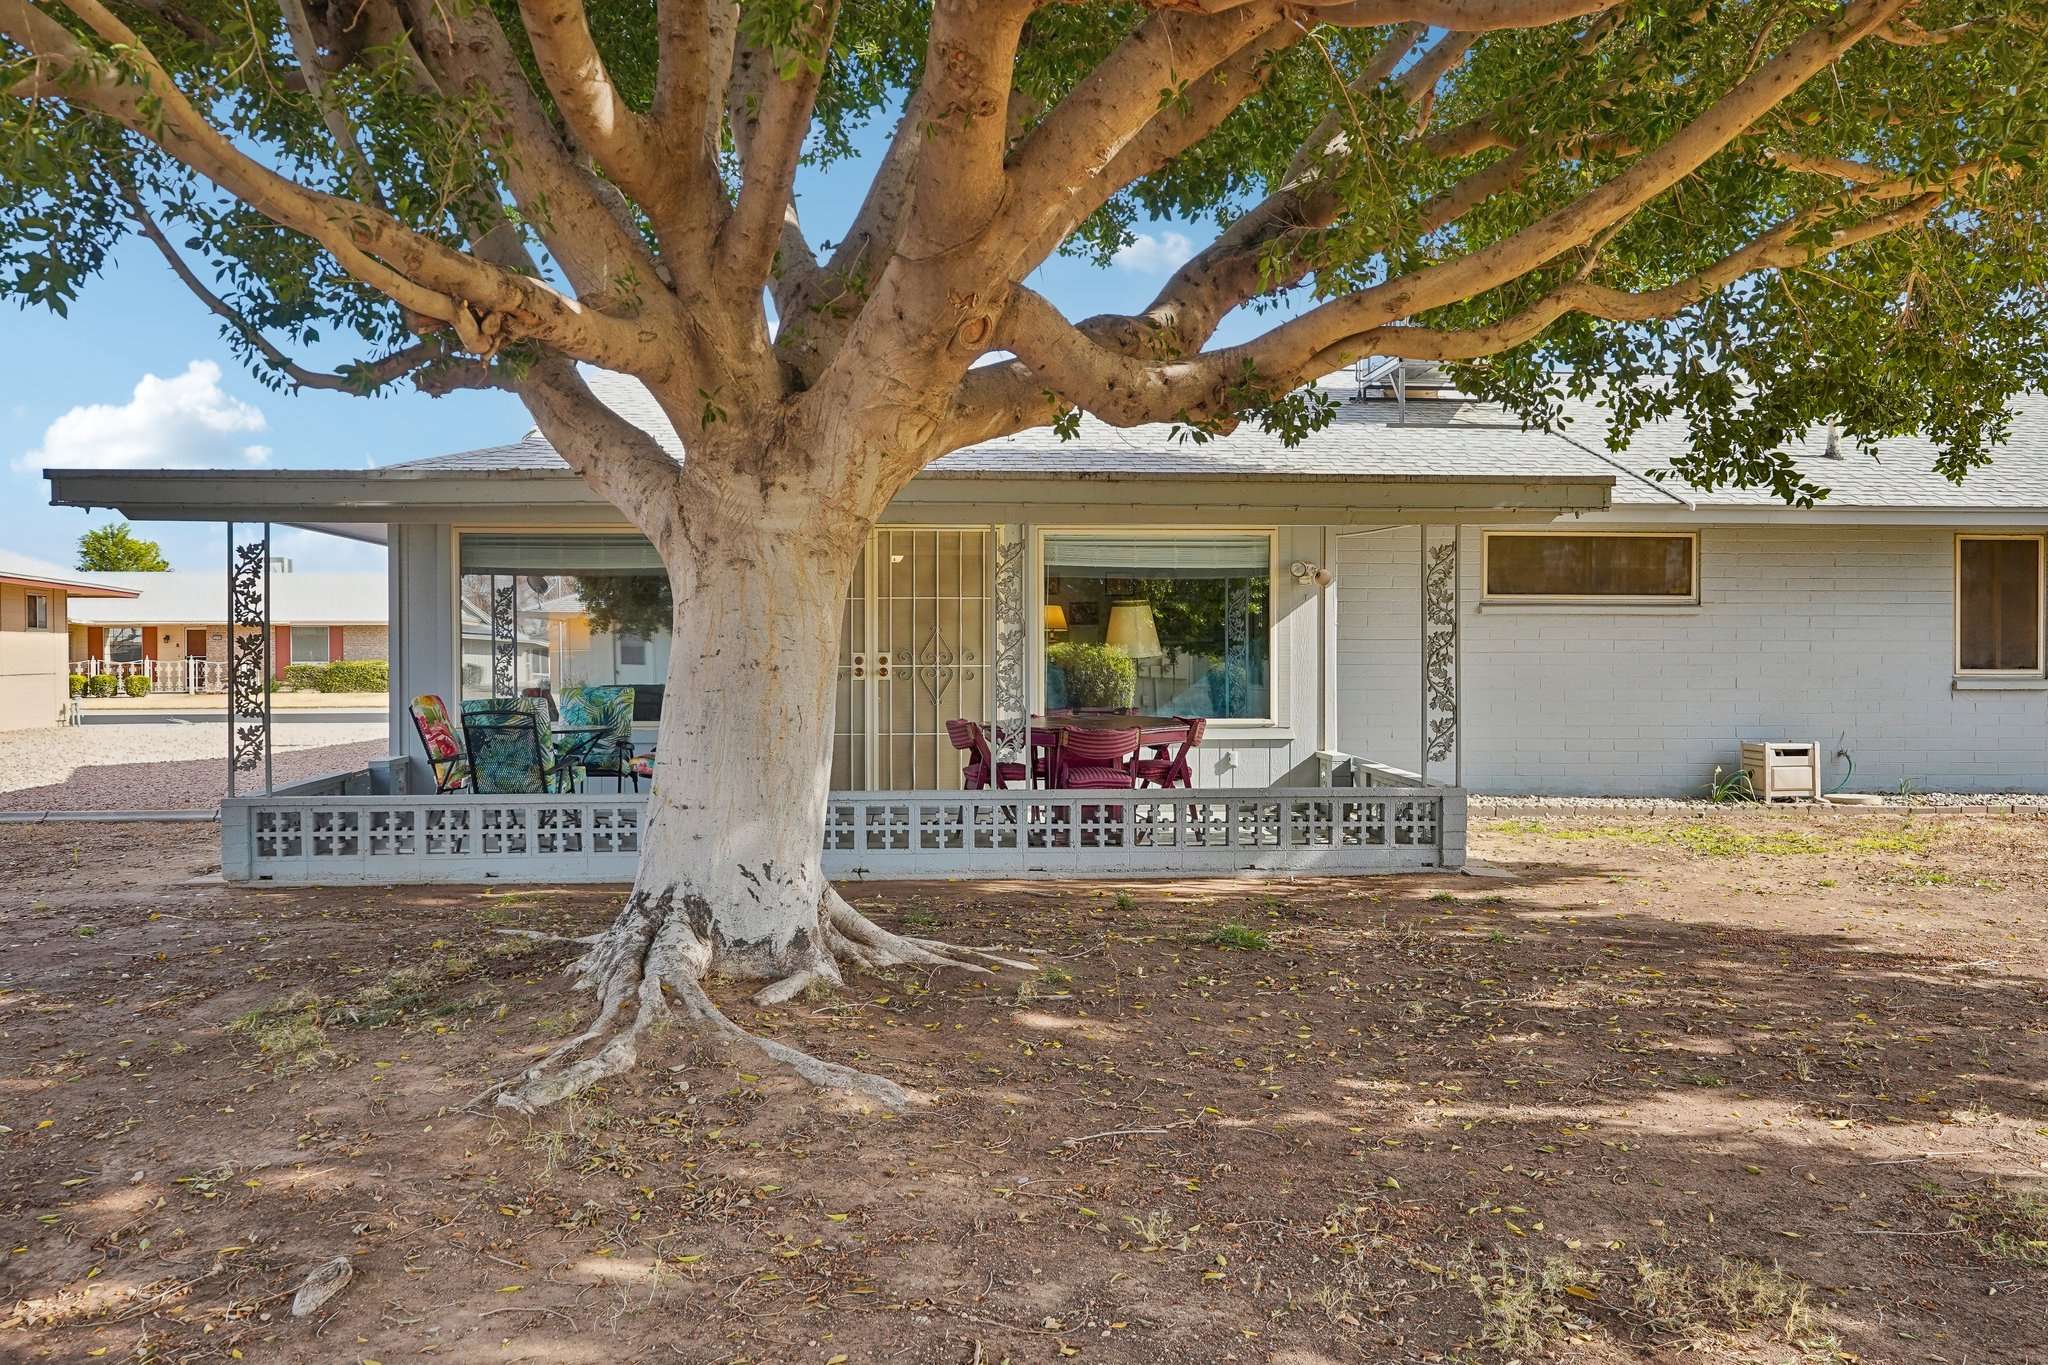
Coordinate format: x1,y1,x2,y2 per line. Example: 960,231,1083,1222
477,886,1034,1113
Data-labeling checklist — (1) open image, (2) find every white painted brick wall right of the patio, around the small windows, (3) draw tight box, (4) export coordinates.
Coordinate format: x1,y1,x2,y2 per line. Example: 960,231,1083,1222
1337,526,2048,796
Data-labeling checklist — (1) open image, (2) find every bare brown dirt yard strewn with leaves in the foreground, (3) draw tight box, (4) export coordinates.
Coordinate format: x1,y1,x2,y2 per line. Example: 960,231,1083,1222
0,814,2048,1365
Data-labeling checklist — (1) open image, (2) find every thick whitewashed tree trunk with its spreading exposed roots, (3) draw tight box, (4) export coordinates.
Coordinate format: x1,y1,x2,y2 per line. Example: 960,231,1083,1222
498,446,1022,1109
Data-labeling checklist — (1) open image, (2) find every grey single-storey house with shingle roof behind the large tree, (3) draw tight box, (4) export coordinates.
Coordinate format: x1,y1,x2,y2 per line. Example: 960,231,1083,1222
49,370,2048,796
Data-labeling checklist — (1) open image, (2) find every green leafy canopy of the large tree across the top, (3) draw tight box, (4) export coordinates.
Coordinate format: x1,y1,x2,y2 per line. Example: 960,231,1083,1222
0,0,2048,505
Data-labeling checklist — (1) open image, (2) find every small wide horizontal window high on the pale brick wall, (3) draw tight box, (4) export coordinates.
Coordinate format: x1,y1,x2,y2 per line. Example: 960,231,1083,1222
1483,530,1700,604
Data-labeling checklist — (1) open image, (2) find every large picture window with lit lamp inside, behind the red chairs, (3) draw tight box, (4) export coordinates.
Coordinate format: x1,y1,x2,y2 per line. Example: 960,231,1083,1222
1044,532,1272,720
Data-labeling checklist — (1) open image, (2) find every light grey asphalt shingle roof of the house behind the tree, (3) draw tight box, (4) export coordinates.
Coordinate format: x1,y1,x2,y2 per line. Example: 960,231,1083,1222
385,372,2048,510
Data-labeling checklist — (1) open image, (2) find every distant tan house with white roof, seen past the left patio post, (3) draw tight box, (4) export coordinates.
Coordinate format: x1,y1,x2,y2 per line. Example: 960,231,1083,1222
70,561,391,692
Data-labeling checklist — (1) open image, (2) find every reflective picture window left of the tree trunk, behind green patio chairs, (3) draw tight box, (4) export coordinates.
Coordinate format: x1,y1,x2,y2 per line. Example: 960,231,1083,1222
461,534,674,718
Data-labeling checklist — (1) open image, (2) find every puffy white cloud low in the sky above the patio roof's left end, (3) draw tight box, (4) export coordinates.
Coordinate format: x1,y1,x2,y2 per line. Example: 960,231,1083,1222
14,360,270,473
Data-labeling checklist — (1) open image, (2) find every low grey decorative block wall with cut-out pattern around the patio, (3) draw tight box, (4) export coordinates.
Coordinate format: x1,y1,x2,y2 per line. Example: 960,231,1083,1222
221,774,1464,884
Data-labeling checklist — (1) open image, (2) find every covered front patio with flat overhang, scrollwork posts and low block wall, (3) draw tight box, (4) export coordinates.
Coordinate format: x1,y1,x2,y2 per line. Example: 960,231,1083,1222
49,378,1612,884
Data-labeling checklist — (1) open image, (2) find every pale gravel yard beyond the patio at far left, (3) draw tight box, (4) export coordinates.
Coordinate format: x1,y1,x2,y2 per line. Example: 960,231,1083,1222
0,722,389,810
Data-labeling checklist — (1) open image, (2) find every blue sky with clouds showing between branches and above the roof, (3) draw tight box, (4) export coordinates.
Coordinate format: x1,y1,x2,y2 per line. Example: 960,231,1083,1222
0,111,1277,571
